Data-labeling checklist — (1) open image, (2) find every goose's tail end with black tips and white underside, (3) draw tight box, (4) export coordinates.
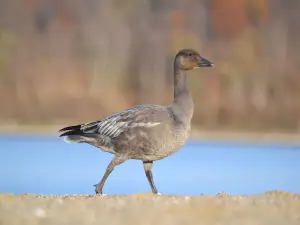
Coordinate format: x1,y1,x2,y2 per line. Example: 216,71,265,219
59,124,85,143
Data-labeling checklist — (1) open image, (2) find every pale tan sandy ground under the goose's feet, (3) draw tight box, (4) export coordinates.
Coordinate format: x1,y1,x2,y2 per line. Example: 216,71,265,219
0,191,300,225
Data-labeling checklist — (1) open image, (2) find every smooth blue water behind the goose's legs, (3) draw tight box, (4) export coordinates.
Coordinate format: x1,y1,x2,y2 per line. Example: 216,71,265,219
0,135,300,194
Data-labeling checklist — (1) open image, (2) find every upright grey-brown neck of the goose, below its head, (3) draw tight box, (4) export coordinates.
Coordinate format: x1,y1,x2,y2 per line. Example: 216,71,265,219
172,64,194,122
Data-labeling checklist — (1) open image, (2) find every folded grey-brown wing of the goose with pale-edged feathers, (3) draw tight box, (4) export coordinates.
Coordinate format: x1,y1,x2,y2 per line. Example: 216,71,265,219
80,105,166,138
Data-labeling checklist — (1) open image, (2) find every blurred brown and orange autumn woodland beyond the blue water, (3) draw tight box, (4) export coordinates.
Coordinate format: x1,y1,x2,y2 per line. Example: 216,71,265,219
0,0,300,132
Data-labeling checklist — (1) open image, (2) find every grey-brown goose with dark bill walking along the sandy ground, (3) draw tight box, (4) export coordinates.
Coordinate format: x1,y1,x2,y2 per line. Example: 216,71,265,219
59,49,214,195
